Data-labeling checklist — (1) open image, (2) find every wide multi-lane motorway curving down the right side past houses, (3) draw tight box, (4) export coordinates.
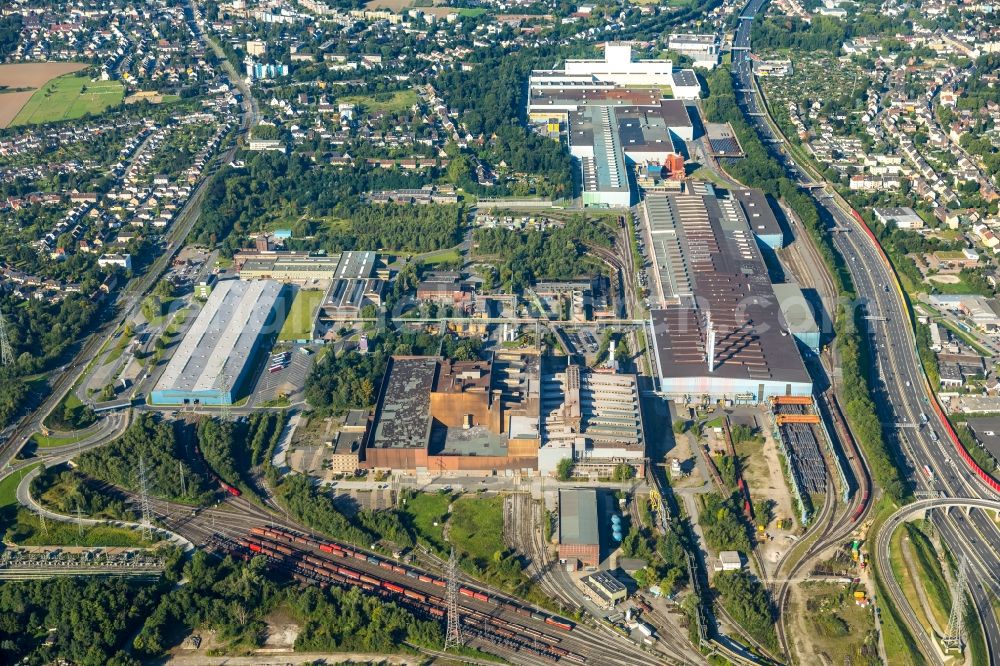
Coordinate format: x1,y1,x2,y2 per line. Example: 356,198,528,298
733,0,1000,664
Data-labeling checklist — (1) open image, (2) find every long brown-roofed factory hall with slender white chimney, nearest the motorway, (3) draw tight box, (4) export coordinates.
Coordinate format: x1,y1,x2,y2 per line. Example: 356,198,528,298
641,181,812,404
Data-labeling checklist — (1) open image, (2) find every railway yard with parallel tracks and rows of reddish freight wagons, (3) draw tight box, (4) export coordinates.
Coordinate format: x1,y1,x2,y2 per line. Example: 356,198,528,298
143,496,680,666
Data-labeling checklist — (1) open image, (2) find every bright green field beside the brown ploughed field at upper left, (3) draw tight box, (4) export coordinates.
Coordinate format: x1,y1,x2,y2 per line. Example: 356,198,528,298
11,75,125,127
